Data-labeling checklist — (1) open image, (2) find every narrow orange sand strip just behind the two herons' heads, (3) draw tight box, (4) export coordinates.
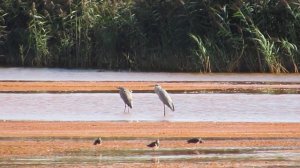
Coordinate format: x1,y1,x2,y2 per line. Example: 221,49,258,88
0,81,300,93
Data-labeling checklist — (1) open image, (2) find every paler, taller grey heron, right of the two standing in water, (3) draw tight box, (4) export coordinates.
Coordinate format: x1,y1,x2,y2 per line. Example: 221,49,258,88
154,84,175,116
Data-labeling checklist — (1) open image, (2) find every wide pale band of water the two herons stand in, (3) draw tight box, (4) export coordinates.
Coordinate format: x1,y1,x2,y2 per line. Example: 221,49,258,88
0,93,300,122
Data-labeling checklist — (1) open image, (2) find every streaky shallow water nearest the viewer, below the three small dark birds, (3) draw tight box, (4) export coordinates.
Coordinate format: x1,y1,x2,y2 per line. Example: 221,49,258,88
0,147,300,166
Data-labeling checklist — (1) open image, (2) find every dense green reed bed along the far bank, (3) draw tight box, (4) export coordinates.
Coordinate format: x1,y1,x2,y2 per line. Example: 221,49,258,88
0,0,300,72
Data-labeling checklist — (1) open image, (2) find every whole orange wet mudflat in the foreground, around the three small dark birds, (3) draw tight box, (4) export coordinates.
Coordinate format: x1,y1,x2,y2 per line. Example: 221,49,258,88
0,121,300,167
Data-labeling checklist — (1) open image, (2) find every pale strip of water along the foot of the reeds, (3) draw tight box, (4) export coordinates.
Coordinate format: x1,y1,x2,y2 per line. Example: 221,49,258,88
0,68,300,82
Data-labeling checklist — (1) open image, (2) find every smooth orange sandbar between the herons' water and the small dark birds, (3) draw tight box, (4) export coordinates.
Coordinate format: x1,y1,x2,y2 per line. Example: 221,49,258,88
0,121,300,138
